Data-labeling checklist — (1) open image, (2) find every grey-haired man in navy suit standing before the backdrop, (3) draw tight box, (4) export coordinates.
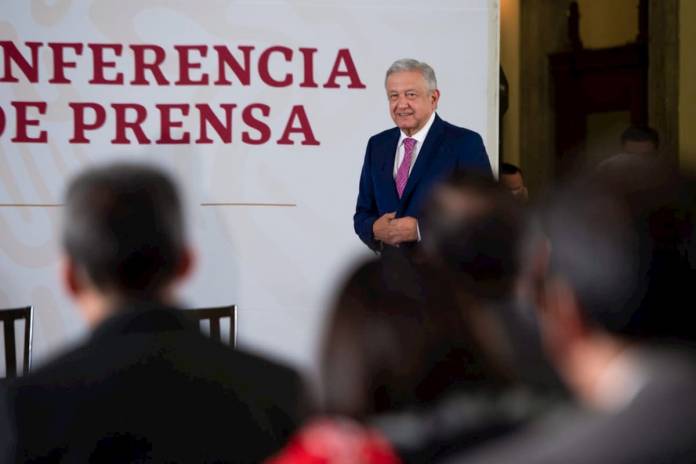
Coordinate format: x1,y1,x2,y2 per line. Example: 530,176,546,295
353,59,492,251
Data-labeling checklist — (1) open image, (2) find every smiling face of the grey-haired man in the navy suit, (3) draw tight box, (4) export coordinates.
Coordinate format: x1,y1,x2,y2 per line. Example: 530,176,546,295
386,71,440,135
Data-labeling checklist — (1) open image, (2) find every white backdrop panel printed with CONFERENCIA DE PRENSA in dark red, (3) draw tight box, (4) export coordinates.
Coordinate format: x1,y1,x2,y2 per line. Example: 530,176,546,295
0,0,498,376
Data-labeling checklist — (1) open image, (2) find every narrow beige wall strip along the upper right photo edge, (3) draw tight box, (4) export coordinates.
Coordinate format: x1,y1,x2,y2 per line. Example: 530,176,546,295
679,0,696,170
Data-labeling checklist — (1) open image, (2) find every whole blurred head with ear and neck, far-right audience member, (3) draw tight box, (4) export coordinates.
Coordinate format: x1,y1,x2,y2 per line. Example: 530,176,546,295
539,157,696,402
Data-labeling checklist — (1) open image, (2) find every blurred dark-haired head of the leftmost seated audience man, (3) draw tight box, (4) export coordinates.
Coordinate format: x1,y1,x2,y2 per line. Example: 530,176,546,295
63,163,191,322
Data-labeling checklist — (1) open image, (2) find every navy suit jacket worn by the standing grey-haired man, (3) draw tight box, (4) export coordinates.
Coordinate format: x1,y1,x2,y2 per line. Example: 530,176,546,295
353,115,493,250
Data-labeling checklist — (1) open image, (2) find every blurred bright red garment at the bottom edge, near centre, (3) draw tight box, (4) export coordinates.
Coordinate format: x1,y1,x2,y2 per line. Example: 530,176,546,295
265,419,401,464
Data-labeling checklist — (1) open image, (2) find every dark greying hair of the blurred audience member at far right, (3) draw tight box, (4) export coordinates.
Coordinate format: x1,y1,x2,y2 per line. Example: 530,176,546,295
544,158,696,339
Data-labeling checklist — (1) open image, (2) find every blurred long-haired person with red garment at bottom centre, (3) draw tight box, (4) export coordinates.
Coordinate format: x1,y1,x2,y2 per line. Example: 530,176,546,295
268,255,548,464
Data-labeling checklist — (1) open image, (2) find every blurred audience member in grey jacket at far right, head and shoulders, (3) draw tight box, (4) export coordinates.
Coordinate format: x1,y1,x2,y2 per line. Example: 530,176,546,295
451,157,696,464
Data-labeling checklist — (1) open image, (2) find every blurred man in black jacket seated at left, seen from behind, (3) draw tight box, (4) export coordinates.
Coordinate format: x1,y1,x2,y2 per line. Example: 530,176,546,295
0,164,300,463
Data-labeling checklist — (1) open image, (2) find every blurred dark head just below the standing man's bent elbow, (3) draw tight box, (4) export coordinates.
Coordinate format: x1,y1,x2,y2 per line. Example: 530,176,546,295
421,171,525,302
